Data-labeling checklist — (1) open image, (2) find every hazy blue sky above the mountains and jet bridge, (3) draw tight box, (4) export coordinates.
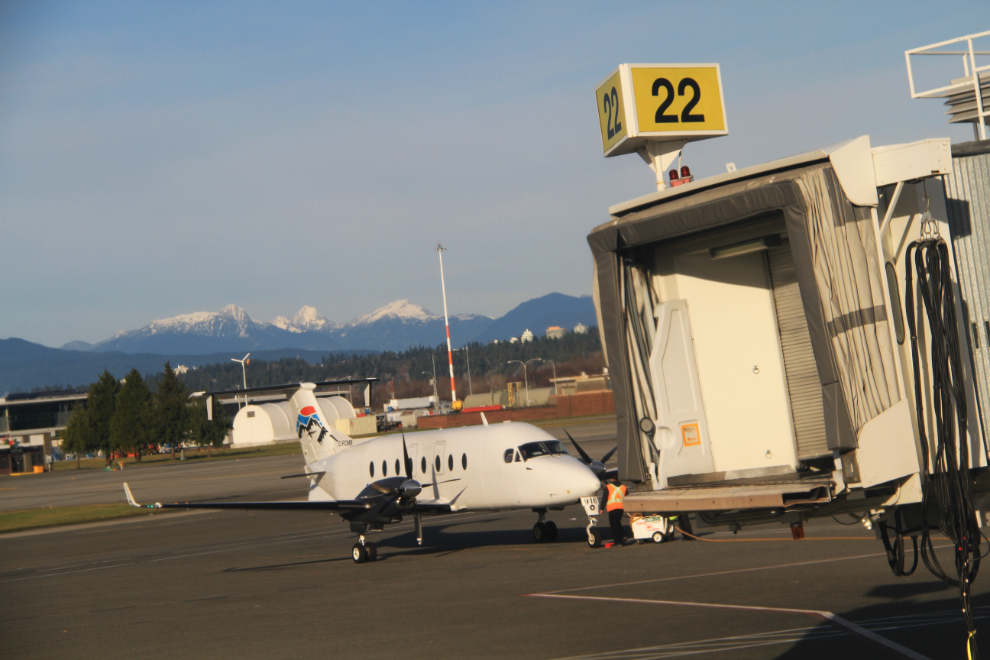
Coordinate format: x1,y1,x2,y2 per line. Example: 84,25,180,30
0,1,990,346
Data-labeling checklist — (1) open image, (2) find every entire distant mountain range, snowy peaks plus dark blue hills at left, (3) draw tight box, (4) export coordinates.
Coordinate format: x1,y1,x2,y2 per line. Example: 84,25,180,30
0,293,596,394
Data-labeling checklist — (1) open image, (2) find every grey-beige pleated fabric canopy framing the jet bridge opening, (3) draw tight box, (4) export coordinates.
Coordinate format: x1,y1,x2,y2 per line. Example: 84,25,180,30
588,136,931,487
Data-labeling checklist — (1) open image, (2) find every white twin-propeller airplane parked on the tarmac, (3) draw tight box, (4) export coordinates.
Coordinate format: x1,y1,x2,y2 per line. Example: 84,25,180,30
124,381,608,563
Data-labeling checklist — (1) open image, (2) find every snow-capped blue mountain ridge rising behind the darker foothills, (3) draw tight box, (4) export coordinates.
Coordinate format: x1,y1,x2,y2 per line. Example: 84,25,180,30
70,293,595,355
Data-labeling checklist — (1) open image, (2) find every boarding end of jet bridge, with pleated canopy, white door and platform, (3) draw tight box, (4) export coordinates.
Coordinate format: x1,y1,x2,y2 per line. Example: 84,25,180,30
588,136,987,524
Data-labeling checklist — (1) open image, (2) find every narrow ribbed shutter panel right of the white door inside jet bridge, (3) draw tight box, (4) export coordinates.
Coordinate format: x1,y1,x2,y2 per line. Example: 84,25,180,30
767,241,831,459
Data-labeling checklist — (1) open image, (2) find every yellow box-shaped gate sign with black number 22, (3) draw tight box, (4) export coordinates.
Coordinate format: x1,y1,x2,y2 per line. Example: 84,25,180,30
595,64,729,156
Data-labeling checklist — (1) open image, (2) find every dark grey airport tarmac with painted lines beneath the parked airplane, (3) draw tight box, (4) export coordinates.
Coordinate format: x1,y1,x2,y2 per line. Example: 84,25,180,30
0,423,990,660
